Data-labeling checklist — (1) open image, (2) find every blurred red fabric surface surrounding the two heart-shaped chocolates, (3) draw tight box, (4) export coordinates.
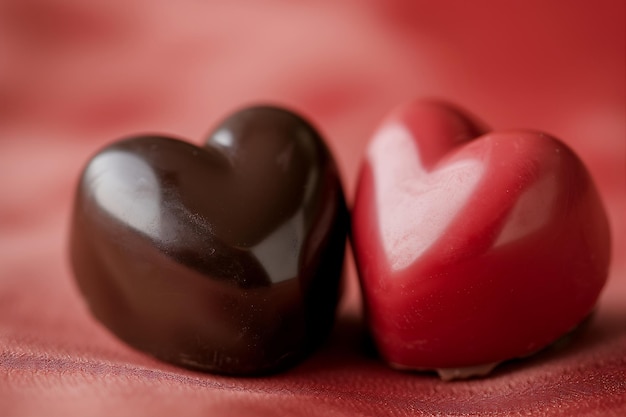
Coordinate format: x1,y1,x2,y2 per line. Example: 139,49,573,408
0,0,626,416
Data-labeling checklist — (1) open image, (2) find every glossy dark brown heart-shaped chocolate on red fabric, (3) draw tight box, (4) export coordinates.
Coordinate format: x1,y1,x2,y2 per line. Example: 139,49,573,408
70,107,348,375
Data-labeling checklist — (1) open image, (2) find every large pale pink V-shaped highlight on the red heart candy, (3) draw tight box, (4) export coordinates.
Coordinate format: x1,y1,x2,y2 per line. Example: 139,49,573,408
367,125,484,271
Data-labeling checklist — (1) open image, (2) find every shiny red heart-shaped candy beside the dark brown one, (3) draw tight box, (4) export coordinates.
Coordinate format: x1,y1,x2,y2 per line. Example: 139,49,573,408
353,103,610,377
